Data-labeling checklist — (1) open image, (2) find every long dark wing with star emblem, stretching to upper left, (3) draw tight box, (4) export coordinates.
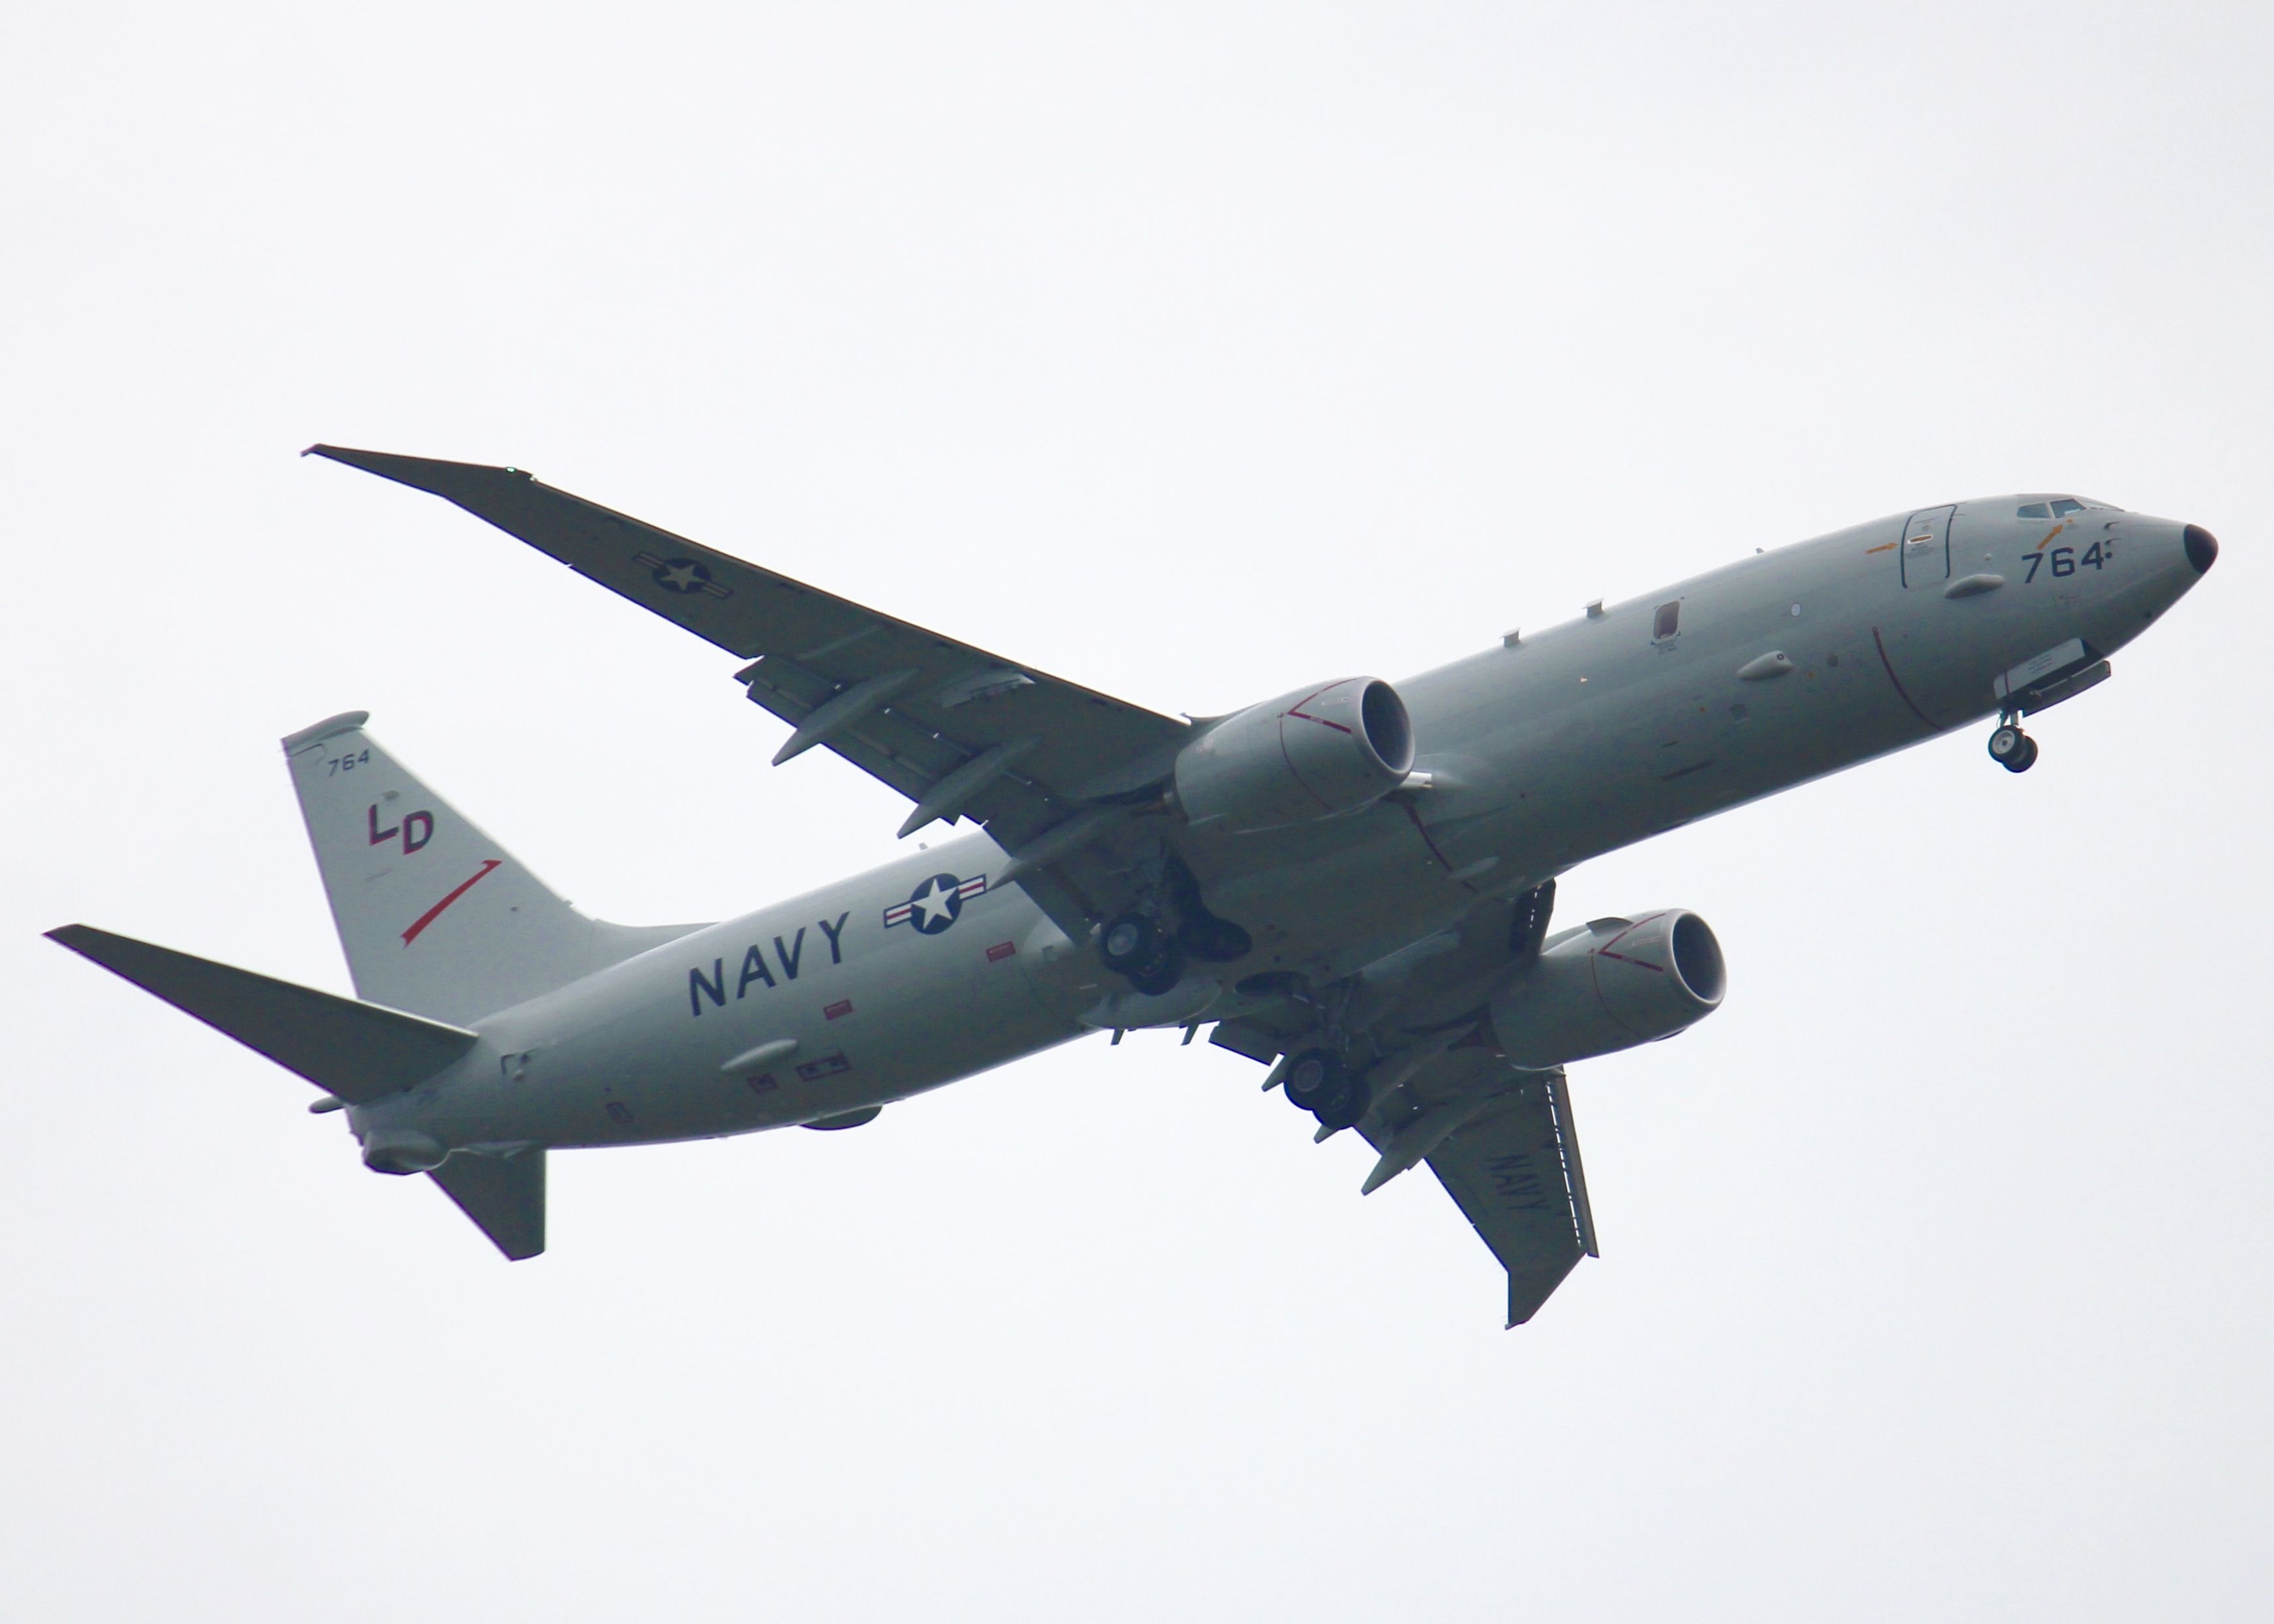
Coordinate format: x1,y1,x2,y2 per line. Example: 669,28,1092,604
307,446,1189,932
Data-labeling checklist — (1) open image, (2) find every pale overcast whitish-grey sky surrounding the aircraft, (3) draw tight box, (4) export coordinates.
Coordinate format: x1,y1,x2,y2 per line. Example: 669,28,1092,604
0,0,2274,1624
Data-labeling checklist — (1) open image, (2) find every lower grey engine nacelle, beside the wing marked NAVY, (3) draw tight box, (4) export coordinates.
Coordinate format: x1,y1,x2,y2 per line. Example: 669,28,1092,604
1489,908,1728,1069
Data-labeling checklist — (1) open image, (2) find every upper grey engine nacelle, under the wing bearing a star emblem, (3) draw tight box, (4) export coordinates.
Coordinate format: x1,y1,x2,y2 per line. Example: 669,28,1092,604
1176,678,1414,834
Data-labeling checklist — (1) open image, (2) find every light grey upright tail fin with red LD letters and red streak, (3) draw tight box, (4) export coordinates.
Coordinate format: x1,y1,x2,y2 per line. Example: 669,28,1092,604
284,710,696,1021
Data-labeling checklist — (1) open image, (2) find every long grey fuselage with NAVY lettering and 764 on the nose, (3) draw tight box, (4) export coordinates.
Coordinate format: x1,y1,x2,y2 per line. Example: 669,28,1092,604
350,496,2201,1146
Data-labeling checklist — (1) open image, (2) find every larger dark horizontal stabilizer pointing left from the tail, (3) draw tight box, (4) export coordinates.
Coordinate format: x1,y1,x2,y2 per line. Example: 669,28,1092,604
48,926,479,1100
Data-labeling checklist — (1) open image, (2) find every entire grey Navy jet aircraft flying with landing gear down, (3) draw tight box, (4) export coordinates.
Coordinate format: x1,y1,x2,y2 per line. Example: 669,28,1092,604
48,446,2219,1323
